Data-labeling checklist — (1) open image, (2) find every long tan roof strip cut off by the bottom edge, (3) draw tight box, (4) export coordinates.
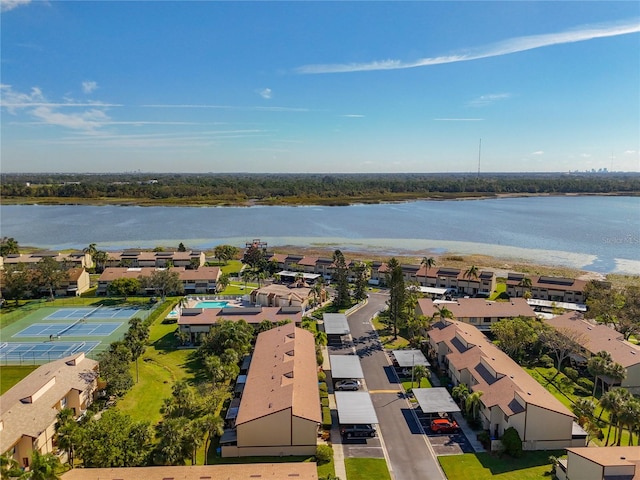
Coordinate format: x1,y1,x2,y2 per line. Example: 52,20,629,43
62,462,318,480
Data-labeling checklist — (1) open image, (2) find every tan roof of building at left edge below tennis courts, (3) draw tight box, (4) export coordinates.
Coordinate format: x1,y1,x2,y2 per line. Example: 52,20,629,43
0,353,98,452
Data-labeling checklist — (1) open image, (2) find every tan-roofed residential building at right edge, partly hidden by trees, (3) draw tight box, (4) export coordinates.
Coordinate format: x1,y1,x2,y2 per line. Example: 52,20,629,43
545,312,640,394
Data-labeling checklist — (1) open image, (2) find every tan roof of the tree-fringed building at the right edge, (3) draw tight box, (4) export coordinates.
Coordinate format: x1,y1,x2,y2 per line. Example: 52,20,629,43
545,312,640,368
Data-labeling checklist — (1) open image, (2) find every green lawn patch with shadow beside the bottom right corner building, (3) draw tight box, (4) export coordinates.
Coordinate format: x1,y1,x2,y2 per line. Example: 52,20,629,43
440,450,564,480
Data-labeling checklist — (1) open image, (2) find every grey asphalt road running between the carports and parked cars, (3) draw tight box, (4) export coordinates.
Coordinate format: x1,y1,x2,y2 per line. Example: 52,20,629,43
342,293,446,480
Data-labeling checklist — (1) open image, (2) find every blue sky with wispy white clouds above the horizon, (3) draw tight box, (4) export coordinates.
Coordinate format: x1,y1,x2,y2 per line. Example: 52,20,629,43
1,0,640,173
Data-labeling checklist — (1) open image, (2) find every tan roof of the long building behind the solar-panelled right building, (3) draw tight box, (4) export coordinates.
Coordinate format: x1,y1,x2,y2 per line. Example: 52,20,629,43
418,298,536,319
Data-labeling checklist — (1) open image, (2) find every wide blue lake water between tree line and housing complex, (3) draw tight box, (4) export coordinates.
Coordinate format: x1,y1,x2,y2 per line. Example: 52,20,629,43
0,196,640,274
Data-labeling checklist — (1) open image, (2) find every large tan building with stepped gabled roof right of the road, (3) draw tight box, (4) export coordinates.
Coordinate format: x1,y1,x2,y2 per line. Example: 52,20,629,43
428,321,586,450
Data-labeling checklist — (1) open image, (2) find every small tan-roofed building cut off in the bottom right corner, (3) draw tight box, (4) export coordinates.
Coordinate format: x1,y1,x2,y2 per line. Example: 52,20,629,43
555,446,640,480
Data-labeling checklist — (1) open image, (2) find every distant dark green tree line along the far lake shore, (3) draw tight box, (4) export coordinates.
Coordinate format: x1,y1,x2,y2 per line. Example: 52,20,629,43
0,173,640,204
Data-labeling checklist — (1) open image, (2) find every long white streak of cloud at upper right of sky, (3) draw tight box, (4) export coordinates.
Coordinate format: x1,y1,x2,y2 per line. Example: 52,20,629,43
294,19,640,74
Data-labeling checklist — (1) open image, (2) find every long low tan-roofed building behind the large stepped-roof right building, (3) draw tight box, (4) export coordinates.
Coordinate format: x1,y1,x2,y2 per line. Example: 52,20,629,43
416,298,536,330
